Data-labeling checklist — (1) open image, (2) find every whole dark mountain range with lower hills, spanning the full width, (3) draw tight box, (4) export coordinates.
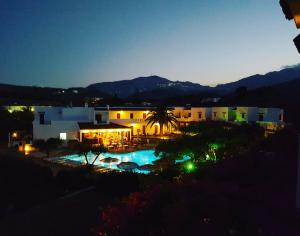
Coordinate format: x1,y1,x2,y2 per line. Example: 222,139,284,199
0,64,300,104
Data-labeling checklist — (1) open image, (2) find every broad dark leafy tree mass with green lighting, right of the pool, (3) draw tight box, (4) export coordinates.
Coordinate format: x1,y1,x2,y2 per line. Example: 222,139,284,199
155,121,264,171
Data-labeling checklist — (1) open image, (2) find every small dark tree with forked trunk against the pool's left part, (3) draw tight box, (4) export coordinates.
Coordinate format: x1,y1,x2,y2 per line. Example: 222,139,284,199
75,142,107,165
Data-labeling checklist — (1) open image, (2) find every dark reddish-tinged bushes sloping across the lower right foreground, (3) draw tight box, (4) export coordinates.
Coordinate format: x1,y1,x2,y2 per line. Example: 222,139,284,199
98,127,300,236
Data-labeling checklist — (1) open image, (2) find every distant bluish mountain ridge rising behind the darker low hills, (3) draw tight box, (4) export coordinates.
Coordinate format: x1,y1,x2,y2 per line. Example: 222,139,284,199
87,64,300,98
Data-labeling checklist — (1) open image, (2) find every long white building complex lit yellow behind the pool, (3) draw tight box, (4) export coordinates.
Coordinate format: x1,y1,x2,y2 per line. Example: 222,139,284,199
33,106,284,142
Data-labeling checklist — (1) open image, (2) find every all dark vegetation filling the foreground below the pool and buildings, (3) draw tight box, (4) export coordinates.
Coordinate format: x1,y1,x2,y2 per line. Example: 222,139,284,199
0,122,300,236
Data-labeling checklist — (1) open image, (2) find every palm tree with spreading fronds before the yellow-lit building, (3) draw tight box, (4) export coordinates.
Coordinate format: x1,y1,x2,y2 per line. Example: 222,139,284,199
146,106,177,135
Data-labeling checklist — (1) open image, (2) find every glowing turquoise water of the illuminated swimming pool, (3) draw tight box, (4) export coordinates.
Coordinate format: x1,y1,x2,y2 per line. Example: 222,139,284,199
59,150,189,174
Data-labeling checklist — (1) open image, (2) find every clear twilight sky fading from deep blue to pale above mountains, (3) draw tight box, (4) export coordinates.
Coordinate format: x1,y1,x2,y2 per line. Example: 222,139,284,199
0,0,299,87
